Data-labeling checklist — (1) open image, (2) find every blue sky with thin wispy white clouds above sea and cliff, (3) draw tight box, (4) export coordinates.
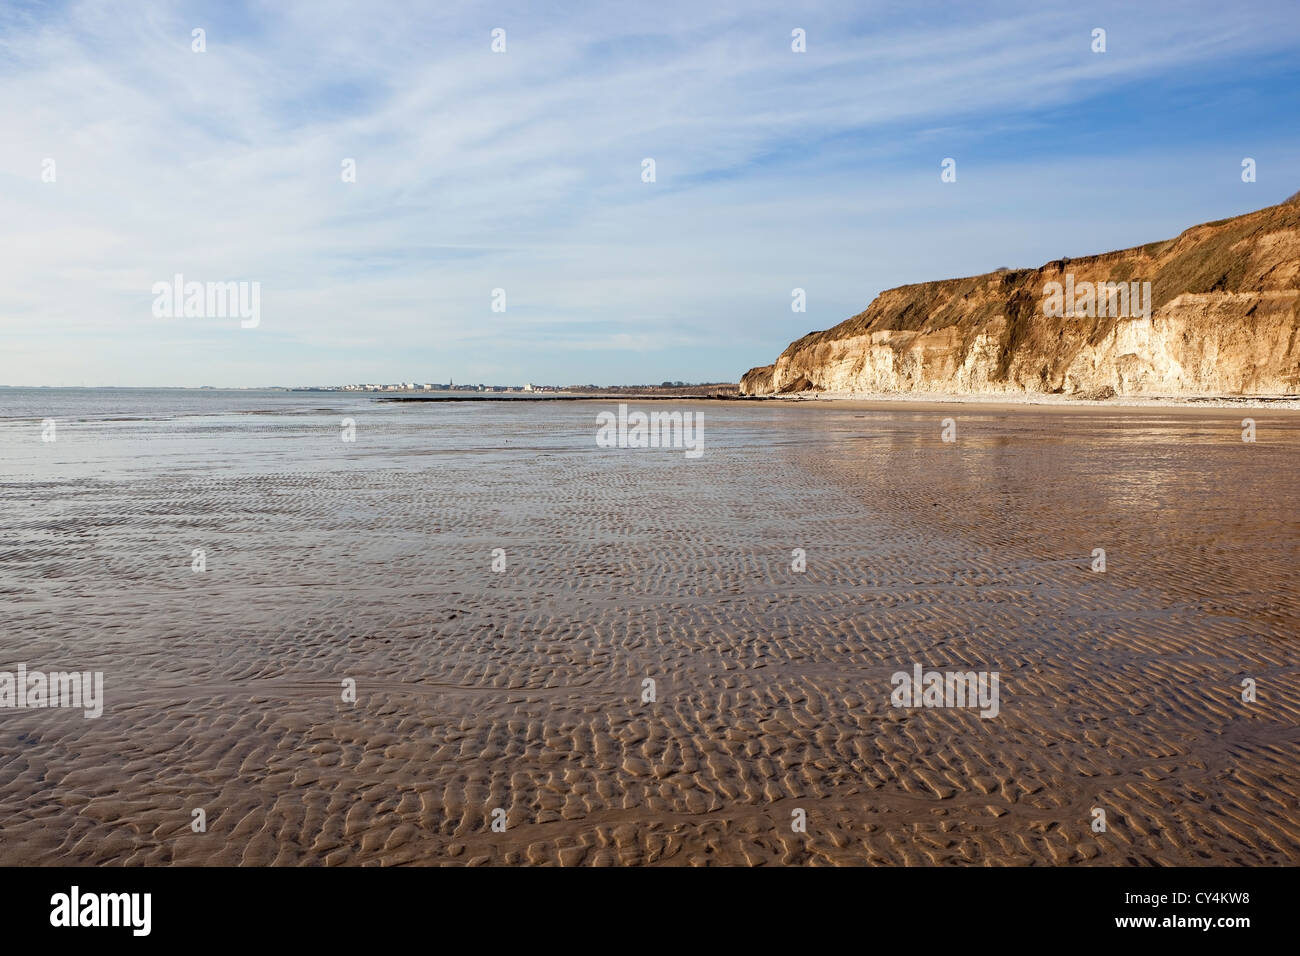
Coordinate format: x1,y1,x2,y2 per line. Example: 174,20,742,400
0,0,1300,386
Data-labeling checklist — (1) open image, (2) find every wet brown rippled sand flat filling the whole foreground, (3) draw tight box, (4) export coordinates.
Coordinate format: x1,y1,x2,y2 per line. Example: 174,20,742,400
0,402,1300,865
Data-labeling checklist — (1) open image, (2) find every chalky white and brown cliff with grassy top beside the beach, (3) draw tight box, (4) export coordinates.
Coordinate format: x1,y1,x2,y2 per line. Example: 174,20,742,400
741,194,1300,398
